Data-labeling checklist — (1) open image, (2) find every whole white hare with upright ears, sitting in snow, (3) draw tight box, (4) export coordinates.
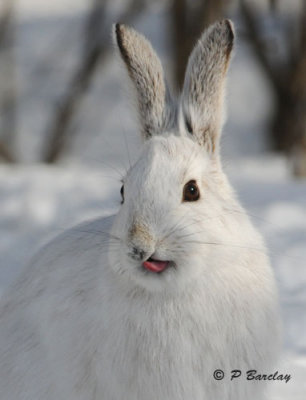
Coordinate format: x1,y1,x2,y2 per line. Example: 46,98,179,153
0,20,279,400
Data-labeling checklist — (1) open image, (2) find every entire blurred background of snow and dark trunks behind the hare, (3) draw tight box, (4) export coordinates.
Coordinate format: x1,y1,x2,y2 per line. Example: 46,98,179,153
0,0,306,400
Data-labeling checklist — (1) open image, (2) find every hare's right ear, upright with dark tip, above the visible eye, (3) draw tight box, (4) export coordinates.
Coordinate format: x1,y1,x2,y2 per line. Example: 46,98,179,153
180,20,234,153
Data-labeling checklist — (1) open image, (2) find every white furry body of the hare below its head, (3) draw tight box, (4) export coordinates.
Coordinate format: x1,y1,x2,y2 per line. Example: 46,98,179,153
0,214,277,400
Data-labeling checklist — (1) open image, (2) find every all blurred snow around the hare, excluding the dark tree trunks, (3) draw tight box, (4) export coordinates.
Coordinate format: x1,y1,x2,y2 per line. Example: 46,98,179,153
0,0,306,400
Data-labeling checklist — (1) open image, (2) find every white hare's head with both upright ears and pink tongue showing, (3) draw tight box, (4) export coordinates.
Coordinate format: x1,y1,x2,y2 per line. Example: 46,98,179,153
113,20,234,290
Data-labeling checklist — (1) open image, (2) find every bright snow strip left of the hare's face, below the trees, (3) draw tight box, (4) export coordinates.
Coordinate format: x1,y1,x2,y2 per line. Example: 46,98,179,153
0,166,119,293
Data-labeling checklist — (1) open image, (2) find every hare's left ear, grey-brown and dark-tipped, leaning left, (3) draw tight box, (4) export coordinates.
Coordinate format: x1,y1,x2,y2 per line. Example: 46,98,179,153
114,24,174,139
